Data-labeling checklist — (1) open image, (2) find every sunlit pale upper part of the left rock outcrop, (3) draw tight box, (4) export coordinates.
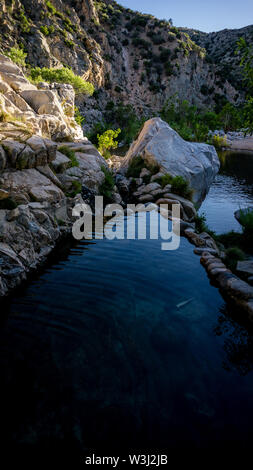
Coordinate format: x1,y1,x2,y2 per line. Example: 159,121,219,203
0,54,83,141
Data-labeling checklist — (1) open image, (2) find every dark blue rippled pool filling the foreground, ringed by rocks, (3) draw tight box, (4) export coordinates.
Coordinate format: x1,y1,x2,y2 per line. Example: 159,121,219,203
0,152,253,460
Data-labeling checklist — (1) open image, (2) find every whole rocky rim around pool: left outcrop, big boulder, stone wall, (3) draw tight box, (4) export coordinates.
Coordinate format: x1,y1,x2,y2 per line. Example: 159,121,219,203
0,56,253,320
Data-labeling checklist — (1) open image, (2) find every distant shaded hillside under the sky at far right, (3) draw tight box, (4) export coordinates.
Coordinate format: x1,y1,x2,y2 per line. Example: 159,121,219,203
180,25,253,94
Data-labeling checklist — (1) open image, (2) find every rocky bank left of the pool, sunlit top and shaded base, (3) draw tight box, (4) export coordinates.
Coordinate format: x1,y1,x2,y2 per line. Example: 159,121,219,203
0,55,107,296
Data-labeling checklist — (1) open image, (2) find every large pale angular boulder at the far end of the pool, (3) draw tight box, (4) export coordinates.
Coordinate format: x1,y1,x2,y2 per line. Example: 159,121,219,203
121,118,220,203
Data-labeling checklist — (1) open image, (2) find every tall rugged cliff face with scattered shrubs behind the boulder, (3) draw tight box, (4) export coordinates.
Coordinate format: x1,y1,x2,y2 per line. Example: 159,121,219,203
0,0,241,120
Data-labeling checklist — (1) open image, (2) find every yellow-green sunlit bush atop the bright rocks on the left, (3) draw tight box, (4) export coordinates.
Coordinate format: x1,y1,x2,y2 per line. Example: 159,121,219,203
30,67,94,95
